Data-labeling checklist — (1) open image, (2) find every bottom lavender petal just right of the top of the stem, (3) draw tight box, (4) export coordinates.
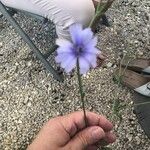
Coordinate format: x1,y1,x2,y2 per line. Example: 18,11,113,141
79,57,90,74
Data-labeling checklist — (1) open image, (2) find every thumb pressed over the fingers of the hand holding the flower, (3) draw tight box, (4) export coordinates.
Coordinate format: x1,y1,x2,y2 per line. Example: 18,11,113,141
68,126,105,150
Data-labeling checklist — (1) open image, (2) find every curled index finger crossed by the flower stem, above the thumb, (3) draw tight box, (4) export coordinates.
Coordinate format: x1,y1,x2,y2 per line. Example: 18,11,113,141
60,111,113,137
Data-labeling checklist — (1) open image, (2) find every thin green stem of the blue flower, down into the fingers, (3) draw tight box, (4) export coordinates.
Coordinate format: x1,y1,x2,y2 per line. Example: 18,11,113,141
77,59,88,127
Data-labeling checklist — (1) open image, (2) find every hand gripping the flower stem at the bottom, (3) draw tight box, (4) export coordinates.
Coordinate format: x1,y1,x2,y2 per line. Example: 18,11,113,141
28,111,116,150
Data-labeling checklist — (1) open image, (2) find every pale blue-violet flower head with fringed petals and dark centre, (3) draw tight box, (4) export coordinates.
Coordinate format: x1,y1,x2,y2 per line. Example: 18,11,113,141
55,24,100,74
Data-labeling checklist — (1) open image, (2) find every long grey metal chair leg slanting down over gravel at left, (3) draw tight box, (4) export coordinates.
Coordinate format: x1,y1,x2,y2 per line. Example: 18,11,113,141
0,2,63,81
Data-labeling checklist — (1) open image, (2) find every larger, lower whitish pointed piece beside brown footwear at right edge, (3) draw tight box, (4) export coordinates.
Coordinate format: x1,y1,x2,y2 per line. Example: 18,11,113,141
134,82,150,97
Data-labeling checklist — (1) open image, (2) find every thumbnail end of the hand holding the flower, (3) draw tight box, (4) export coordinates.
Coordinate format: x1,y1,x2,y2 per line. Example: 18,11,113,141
92,127,105,141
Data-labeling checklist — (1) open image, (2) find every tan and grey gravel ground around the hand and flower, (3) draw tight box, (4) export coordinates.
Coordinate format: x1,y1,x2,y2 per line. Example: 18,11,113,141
0,0,150,150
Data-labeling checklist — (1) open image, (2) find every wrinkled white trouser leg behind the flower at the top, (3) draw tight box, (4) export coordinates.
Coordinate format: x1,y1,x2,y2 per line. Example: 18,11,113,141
1,0,98,39
